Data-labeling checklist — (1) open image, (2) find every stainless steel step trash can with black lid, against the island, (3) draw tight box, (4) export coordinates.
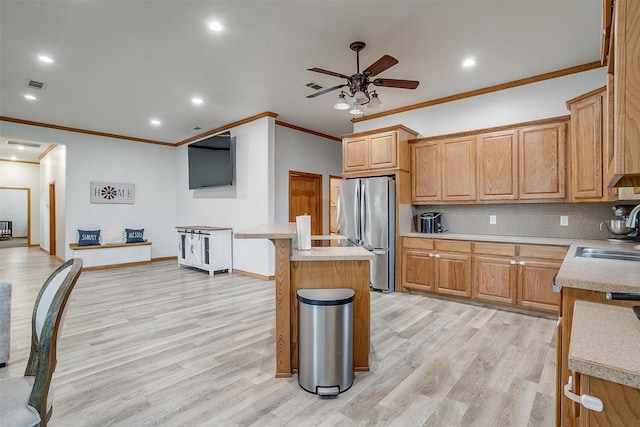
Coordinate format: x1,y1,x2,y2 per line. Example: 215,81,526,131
297,289,355,396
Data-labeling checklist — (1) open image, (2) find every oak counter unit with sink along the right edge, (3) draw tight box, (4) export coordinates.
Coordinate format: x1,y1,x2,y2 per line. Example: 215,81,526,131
556,240,640,426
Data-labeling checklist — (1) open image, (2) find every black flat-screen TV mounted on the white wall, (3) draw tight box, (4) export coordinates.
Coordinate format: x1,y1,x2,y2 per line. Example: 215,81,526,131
188,134,235,190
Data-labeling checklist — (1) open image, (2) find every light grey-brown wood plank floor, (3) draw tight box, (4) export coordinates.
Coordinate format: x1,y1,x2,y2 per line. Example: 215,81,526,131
0,248,556,427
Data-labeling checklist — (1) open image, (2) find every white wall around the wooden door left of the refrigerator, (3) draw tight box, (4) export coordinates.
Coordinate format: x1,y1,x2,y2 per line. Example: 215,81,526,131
275,126,342,234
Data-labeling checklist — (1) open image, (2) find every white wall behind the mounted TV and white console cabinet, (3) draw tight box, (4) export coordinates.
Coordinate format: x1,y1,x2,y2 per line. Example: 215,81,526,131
175,117,275,276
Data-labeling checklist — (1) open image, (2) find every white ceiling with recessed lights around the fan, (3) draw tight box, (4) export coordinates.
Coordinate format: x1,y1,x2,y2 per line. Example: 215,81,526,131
0,0,602,159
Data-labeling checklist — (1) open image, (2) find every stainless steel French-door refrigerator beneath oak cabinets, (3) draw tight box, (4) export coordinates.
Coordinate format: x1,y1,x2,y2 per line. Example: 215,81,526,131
338,177,396,292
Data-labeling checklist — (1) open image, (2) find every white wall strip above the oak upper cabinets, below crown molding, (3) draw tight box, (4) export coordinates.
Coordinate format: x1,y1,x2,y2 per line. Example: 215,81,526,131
354,68,606,137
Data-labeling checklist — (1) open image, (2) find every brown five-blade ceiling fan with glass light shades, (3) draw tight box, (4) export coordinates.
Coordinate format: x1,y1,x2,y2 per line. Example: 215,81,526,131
307,42,420,115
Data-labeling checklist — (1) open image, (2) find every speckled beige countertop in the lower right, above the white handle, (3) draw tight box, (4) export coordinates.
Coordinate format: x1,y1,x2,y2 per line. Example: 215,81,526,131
568,301,640,389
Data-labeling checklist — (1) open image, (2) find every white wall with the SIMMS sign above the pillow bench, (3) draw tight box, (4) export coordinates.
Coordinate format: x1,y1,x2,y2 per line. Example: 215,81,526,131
2,122,176,259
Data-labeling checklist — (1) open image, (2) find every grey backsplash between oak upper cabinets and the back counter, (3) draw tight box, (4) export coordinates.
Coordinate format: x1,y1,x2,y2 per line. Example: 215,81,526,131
400,202,633,239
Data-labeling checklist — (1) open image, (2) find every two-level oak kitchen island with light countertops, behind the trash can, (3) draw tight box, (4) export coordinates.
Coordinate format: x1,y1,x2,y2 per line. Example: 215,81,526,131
235,223,374,378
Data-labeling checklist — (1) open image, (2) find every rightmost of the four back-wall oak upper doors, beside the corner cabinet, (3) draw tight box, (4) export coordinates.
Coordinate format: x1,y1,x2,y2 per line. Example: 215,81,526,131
518,122,567,200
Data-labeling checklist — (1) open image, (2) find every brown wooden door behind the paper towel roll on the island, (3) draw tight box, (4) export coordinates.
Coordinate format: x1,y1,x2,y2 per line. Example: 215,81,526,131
289,171,323,235
